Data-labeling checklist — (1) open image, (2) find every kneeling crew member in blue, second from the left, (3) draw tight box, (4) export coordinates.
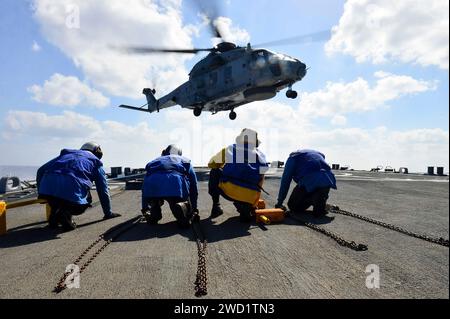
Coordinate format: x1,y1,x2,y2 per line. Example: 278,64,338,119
142,145,198,228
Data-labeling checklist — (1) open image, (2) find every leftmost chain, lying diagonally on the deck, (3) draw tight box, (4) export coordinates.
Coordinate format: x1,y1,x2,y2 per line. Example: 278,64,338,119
53,216,144,293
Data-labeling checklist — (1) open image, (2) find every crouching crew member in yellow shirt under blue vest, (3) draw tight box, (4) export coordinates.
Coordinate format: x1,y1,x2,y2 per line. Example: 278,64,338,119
208,129,268,222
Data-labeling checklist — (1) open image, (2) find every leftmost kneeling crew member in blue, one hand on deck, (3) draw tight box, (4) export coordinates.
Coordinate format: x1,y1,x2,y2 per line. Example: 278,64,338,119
36,142,120,230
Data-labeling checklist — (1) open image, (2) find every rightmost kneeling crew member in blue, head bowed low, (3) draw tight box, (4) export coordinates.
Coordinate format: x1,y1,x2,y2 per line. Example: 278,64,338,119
275,150,337,217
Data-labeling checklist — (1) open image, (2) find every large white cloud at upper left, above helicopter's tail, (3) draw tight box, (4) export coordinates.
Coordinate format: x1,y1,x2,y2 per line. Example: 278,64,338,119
34,0,195,98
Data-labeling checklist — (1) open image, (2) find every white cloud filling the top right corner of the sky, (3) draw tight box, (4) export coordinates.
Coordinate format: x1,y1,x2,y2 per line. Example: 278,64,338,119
326,0,449,70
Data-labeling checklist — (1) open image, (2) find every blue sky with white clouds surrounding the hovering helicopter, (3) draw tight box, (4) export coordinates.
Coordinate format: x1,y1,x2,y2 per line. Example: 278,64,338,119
0,0,449,171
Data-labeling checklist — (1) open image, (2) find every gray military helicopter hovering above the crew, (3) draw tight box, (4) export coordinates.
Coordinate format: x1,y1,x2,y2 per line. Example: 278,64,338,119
120,7,326,120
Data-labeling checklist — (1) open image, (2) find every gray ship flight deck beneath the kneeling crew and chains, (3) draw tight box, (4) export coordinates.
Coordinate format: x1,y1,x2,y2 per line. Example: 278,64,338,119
0,171,449,299
